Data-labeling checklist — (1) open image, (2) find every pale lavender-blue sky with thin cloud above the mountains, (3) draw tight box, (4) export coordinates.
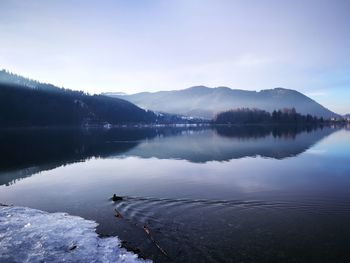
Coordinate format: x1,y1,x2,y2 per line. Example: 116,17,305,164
0,0,350,114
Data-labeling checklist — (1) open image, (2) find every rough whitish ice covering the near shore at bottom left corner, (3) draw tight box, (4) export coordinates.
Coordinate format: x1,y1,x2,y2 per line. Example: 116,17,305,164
0,206,151,262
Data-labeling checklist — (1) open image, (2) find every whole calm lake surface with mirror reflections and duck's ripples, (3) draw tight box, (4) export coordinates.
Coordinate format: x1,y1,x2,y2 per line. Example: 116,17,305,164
0,127,350,263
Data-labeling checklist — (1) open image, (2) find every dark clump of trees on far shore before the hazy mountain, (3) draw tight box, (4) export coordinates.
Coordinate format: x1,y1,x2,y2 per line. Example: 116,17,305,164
214,108,324,124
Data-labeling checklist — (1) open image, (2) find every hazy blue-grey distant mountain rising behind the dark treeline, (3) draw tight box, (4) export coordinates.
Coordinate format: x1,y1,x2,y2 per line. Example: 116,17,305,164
105,86,338,119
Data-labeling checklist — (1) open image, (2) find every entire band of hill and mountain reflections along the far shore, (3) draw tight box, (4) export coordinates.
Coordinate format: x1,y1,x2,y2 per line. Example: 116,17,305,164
0,125,334,185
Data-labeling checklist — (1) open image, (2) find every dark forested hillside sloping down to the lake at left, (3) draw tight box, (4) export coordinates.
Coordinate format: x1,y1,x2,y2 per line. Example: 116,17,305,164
0,70,157,126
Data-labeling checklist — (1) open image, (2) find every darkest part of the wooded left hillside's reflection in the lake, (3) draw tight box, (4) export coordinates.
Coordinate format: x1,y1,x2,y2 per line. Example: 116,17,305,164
0,127,205,176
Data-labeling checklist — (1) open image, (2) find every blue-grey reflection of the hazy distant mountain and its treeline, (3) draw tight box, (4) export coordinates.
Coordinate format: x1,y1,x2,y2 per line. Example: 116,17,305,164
126,126,335,163
